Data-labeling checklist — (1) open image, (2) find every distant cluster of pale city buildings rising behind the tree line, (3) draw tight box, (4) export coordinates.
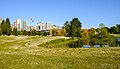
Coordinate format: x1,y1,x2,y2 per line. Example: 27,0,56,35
0,18,61,31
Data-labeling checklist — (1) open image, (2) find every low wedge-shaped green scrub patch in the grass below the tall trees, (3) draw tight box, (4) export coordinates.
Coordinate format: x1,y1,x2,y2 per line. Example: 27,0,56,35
39,37,83,48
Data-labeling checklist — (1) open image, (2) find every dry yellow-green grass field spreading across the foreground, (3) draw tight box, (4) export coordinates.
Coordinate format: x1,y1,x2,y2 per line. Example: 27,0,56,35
0,36,120,69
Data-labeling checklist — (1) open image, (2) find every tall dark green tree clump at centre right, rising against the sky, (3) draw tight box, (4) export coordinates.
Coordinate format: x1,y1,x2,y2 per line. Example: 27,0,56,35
64,18,81,38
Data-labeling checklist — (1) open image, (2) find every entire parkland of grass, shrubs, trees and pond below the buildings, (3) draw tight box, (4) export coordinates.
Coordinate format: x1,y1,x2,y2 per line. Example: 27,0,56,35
0,18,120,69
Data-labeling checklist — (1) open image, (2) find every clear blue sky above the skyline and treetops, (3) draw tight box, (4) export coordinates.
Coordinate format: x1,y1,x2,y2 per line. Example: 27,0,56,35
0,0,120,28
